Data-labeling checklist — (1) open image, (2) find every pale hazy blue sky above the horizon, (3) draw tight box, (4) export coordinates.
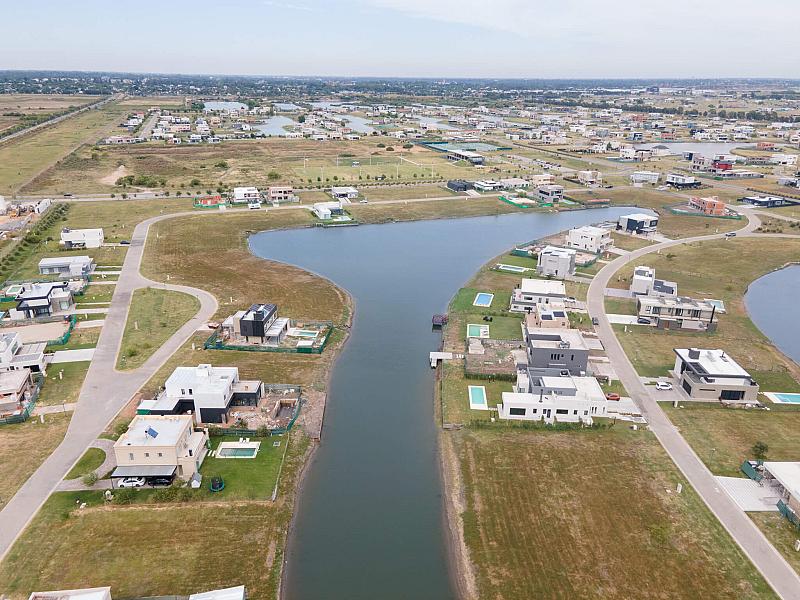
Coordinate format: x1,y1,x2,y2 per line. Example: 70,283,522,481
0,0,800,77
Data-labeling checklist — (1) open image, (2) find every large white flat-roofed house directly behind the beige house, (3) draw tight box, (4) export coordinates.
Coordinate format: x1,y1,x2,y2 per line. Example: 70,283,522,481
145,364,264,423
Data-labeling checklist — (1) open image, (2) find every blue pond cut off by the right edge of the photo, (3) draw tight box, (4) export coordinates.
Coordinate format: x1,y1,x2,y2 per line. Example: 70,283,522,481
744,265,800,366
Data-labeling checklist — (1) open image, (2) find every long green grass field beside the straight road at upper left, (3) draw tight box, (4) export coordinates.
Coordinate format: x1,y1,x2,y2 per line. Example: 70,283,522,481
0,103,125,195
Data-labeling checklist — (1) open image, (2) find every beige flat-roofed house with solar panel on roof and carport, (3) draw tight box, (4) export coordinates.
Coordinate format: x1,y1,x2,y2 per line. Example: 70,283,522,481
111,415,208,484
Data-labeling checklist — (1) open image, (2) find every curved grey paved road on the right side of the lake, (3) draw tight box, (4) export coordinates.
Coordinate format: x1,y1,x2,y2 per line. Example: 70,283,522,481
588,213,800,600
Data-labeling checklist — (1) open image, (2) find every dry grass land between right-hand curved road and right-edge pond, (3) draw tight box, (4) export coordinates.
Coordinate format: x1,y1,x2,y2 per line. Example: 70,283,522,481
613,239,800,384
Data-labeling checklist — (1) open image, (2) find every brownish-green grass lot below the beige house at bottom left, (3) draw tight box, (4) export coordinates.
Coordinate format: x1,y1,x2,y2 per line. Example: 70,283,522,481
0,432,308,600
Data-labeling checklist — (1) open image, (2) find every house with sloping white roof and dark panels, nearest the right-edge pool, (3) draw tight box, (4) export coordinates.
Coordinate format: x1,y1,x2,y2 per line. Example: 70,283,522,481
674,348,758,403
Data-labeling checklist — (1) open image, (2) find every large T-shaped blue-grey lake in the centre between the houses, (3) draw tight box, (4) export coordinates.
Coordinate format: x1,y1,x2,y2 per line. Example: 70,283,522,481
250,208,630,600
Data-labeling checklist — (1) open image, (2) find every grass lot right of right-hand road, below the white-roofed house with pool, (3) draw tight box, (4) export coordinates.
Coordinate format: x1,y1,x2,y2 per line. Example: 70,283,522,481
660,402,800,476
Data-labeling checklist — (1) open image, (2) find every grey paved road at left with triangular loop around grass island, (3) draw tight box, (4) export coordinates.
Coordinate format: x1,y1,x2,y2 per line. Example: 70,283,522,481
0,215,217,559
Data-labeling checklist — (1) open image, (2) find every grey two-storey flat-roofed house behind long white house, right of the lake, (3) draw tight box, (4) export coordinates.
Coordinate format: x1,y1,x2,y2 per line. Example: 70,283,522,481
523,324,589,376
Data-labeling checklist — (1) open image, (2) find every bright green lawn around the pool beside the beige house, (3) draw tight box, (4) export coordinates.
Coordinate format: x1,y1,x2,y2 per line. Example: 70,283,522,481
200,435,289,500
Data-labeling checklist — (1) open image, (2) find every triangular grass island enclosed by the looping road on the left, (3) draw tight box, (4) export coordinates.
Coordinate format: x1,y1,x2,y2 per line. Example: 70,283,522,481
117,287,200,370
